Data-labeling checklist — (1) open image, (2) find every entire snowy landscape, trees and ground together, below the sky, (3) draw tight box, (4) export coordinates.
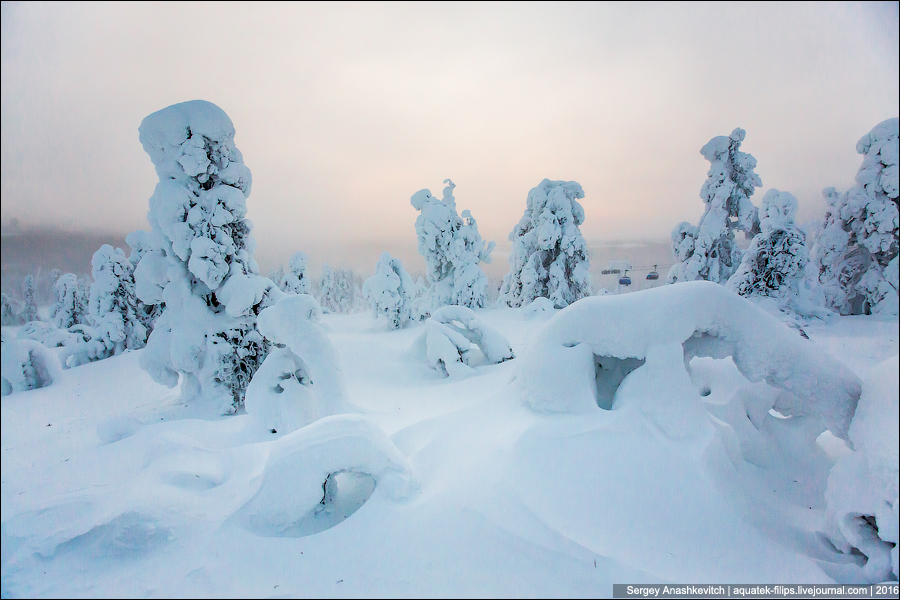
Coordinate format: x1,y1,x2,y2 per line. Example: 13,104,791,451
2,100,900,597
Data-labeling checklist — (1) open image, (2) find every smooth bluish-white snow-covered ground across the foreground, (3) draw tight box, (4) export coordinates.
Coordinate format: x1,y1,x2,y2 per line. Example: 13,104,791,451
2,298,900,598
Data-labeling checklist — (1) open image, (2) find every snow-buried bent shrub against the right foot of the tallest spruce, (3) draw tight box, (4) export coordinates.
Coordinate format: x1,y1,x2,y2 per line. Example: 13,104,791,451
245,294,354,434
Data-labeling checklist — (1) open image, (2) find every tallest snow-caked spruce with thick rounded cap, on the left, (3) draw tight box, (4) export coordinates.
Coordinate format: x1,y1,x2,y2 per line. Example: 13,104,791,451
135,100,281,413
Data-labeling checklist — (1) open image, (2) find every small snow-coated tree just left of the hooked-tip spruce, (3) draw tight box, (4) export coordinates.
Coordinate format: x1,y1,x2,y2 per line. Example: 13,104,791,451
362,252,416,329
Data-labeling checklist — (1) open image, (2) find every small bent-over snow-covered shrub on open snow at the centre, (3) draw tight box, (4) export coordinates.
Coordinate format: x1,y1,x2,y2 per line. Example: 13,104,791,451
425,306,515,377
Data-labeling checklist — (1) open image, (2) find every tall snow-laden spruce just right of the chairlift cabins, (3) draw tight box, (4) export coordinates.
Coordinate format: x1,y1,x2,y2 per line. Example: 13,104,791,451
666,128,762,284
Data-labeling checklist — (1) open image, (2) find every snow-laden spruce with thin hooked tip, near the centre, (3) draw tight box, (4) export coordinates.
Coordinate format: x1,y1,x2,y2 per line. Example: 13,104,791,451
410,179,494,309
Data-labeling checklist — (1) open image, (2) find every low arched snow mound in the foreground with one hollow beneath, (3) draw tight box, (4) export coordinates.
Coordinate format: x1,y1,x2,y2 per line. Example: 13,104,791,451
246,415,416,536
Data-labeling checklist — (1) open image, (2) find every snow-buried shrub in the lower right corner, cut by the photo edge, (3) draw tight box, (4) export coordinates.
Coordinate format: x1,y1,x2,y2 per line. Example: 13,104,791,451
825,356,900,583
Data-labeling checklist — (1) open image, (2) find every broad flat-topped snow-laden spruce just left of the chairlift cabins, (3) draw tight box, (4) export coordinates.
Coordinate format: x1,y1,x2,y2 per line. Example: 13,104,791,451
499,179,591,308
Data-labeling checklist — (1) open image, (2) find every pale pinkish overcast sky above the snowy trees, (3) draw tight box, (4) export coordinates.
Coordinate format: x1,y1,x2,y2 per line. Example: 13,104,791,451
0,2,900,272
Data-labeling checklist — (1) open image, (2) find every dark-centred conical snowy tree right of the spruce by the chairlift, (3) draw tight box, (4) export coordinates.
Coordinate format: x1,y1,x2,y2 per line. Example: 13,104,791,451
726,189,809,302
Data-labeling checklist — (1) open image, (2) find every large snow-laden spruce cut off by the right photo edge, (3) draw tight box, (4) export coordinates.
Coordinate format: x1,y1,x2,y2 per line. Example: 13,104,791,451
812,118,900,315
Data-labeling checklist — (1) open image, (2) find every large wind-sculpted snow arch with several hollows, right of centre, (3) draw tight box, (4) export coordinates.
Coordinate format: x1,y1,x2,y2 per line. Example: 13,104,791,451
518,282,860,439
